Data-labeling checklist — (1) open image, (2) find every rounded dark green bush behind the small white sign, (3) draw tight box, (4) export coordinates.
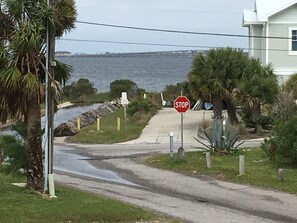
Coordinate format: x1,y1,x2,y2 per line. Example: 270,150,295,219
109,79,138,98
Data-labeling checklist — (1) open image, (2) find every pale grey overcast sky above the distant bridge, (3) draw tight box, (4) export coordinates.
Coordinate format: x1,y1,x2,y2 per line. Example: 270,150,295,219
56,0,254,53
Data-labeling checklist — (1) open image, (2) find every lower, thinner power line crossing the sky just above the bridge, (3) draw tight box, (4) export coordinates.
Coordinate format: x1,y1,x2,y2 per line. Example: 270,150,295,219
59,38,289,52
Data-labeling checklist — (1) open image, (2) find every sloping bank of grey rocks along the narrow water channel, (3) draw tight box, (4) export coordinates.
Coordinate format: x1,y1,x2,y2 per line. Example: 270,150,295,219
54,102,121,137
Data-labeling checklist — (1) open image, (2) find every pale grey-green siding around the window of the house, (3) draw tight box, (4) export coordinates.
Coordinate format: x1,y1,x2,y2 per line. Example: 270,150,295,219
268,23,297,70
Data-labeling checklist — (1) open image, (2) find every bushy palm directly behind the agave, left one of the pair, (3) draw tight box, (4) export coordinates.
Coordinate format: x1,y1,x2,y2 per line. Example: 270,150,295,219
188,48,246,123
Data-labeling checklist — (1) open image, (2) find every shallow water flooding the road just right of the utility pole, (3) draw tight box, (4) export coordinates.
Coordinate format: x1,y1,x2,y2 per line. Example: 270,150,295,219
54,146,137,186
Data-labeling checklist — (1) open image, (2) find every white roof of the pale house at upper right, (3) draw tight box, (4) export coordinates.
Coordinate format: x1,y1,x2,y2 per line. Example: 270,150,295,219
243,0,297,26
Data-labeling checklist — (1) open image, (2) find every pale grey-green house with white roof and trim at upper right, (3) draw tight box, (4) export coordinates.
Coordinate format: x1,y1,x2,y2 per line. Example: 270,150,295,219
242,0,297,82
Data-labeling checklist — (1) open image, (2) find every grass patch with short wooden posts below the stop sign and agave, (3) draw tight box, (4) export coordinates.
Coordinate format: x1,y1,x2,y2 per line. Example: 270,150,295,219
146,149,297,194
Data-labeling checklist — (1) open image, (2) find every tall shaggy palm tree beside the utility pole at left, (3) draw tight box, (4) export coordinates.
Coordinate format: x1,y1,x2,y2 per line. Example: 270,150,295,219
0,0,76,191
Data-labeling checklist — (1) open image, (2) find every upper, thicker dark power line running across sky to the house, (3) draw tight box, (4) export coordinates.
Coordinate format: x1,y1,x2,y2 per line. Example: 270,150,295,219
76,21,292,40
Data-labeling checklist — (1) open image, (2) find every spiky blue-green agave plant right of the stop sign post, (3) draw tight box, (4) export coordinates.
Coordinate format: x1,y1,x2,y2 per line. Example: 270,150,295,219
194,119,244,153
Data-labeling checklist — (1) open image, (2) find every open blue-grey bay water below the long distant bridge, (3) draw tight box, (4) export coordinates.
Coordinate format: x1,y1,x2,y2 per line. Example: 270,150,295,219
57,56,192,92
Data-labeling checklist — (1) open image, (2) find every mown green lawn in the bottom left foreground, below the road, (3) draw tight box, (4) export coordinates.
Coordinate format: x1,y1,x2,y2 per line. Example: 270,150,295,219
0,172,176,223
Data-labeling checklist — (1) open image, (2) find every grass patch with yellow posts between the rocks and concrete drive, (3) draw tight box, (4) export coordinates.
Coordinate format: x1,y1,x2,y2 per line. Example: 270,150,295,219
71,109,152,144
